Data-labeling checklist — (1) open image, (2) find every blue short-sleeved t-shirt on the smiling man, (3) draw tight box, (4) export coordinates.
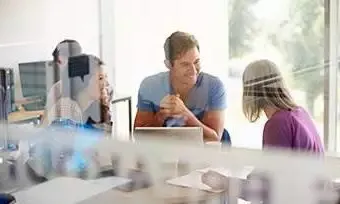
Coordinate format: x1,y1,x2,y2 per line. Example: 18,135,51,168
137,72,226,126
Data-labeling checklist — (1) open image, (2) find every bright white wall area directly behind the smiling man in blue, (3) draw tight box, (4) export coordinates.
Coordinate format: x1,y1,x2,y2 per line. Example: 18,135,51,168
102,0,228,136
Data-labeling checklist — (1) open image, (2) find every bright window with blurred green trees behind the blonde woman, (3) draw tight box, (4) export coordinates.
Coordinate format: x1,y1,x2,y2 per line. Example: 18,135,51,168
227,0,325,148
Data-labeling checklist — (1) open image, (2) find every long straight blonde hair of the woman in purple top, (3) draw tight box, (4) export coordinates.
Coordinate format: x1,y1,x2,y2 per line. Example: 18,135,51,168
243,60,297,122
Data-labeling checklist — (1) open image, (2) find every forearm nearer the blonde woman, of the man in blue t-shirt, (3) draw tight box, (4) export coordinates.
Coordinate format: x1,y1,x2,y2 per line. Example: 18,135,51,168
186,113,220,142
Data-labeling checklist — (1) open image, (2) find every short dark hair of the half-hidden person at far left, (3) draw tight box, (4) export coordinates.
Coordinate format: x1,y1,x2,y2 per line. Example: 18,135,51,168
52,39,82,61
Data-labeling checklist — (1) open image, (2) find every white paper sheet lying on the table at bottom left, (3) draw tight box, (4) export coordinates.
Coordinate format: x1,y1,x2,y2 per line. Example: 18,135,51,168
13,177,129,204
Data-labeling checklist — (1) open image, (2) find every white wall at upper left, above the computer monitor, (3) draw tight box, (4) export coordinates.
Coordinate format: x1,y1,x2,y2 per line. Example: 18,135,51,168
0,0,99,98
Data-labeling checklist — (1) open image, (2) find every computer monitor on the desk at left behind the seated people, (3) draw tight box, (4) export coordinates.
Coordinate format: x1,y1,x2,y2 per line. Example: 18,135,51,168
19,61,55,111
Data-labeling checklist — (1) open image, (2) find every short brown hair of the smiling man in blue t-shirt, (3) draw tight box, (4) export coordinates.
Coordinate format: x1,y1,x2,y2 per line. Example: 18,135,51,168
164,31,200,63
